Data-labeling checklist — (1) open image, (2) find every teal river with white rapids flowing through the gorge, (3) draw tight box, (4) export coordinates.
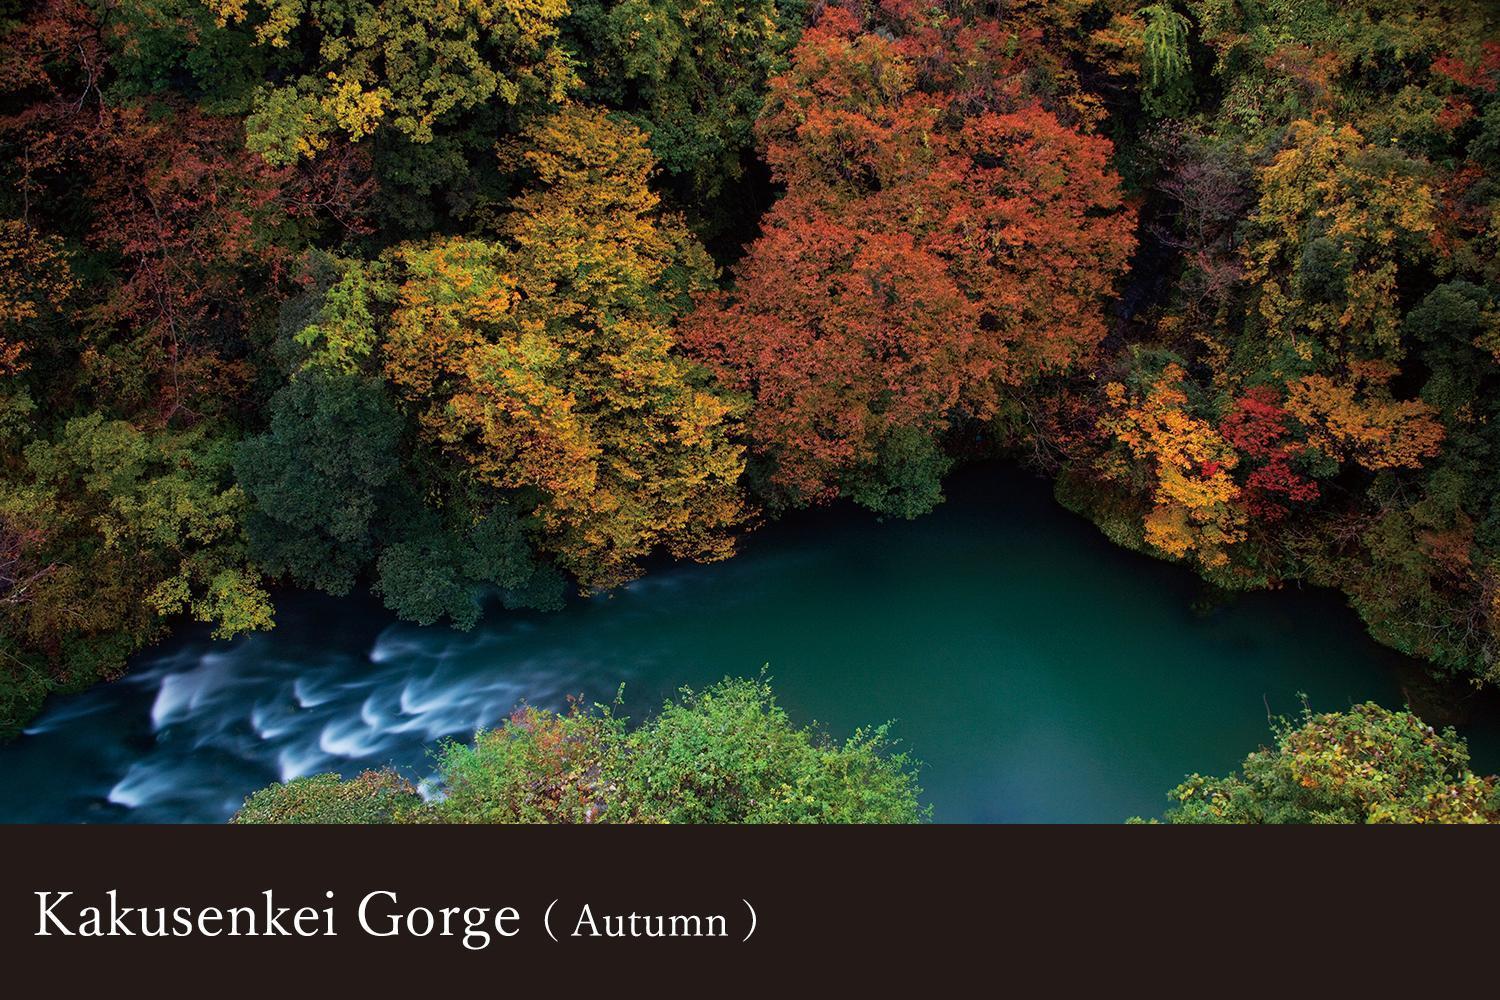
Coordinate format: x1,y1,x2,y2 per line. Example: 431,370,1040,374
0,468,1500,823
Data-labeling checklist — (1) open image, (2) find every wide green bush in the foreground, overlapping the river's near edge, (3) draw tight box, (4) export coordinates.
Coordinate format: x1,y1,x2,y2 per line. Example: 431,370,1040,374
234,679,929,823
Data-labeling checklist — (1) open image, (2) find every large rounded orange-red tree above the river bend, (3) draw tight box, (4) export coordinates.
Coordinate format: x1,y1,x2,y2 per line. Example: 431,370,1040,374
684,7,1134,516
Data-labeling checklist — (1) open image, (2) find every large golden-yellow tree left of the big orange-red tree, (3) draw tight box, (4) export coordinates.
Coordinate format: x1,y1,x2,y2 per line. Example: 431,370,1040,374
386,106,746,589
